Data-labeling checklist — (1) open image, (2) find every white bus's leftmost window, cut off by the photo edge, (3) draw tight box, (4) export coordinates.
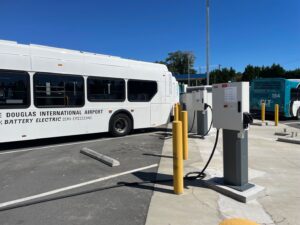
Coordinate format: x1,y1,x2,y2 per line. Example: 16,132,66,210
0,70,30,109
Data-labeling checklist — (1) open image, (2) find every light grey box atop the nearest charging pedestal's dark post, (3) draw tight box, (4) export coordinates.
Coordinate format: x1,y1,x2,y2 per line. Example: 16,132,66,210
212,82,249,131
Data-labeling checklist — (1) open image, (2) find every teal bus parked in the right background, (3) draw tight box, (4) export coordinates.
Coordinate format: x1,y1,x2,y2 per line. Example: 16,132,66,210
250,78,300,119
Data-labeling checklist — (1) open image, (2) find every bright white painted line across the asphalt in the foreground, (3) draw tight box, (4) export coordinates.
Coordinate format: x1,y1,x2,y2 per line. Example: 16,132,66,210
0,164,158,209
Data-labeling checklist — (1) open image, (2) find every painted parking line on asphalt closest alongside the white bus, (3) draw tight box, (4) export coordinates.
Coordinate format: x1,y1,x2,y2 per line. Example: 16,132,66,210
0,131,157,155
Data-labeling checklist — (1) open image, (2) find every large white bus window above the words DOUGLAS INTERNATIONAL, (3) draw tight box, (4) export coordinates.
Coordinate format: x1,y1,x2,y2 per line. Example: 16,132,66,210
33,73,84,108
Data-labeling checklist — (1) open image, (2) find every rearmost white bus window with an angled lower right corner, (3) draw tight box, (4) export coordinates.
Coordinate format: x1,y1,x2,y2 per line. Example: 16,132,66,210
128,80,157,102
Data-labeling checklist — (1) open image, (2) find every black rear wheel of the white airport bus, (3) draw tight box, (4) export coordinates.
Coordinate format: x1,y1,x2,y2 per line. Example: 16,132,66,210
109,113,132,137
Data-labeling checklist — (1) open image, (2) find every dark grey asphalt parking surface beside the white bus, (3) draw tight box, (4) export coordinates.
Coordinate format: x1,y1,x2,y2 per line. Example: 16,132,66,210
0,130,163,225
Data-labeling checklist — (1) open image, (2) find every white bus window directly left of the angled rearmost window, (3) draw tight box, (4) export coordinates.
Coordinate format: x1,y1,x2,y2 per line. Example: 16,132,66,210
87,77,125,102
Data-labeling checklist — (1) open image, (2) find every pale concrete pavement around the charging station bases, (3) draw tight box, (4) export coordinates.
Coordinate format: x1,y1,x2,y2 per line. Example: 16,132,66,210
146,122,300,225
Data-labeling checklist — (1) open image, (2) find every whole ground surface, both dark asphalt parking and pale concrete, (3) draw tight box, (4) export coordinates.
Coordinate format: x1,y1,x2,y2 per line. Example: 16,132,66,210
0,120,300,225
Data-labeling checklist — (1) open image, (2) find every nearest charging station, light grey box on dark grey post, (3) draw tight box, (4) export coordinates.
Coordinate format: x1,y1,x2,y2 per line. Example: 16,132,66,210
212,82,254,191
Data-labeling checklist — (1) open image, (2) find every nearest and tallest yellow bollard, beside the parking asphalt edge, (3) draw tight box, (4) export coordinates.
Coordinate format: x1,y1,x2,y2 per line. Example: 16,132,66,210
173,121,183,195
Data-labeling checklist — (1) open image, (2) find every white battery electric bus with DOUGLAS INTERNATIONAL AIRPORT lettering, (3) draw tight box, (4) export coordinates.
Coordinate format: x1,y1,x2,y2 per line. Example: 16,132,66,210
0,41,179,143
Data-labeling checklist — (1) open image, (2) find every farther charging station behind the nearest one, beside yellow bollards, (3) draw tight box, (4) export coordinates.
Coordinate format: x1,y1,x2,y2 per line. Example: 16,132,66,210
182,86,212,136
